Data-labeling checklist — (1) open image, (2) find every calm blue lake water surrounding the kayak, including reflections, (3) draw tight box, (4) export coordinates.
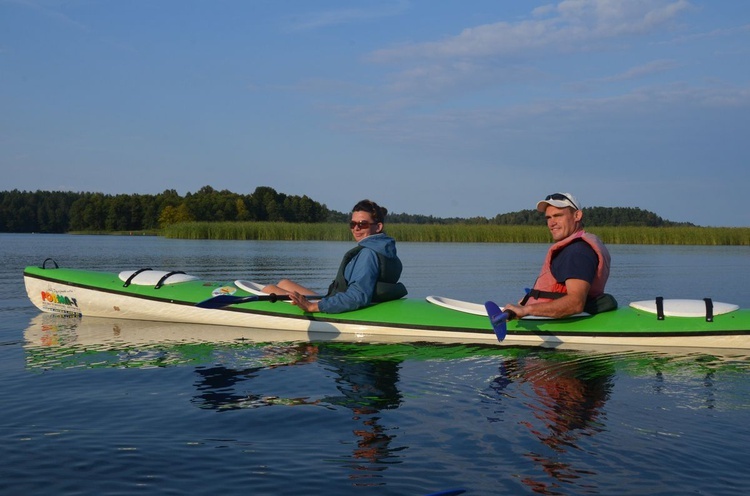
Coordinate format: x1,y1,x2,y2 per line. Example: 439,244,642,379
0,234,750,495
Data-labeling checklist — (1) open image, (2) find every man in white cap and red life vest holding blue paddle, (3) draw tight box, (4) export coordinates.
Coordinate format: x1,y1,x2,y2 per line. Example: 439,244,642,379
505,193,617,318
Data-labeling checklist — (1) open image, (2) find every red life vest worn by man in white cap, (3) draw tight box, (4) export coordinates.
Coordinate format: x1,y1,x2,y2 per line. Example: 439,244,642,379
522,230,611,305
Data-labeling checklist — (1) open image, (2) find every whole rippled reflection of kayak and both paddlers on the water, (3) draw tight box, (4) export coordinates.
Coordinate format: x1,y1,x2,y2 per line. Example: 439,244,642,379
24,314,750,494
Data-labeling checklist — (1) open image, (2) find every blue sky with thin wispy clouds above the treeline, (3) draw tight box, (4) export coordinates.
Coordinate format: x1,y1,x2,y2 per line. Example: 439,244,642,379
0,0,750,226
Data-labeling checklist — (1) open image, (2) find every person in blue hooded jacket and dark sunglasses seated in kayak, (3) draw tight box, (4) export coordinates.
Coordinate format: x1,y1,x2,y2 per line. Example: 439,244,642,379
263,200,407,313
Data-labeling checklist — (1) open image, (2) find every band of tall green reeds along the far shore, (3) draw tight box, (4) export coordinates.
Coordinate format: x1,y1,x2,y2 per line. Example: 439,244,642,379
161,222,750,246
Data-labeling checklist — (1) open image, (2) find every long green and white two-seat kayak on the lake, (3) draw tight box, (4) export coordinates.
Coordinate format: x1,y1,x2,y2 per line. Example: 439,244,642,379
24,259,750,349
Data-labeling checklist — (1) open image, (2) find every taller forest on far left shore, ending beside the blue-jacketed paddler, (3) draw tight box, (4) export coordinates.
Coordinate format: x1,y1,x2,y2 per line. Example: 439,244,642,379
0,186,332,233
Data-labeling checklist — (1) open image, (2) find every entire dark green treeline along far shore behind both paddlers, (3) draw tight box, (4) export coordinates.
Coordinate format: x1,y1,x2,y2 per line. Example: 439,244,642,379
0,186,693,233
